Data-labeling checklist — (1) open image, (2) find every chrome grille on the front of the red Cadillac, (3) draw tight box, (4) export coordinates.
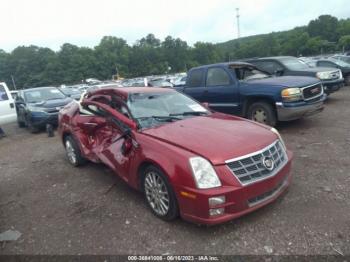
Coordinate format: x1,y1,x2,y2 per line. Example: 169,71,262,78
226,140,288,185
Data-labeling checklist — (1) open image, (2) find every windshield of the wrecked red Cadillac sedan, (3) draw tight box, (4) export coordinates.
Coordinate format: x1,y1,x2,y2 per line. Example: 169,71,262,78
127,92,209,128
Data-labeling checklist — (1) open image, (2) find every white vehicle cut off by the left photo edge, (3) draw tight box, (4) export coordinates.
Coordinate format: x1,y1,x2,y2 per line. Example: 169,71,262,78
0,82,17,125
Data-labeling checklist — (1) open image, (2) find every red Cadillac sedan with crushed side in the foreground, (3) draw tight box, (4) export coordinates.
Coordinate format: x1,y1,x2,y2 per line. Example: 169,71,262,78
59,87,293,224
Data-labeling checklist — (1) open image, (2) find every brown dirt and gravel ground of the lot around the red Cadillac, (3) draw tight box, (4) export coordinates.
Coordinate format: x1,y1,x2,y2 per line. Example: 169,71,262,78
0,87,350,255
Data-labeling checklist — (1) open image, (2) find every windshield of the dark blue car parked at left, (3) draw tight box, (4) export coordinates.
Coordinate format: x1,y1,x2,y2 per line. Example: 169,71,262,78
24,87,66,103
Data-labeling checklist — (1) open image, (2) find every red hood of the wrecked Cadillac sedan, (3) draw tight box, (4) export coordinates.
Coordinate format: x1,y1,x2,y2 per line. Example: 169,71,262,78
142,113,277,165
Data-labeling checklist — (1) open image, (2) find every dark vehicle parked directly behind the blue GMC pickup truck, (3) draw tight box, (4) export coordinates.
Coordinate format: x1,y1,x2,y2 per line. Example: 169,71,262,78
245,56,344,95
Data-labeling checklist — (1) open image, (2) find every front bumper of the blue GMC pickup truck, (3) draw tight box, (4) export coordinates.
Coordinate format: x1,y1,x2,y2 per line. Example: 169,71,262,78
276,95,327,121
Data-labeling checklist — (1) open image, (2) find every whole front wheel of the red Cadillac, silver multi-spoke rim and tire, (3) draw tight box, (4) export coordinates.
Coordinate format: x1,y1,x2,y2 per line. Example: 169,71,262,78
142,166,179,221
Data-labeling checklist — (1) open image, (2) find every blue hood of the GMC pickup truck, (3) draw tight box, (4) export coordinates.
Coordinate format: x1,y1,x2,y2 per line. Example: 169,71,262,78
245,76,320,87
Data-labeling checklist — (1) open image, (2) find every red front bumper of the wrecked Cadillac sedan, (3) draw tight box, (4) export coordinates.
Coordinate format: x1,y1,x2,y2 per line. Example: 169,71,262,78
175,151,293,225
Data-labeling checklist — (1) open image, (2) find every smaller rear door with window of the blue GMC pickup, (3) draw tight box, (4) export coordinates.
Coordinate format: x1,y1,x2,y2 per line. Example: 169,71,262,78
183,68,206,102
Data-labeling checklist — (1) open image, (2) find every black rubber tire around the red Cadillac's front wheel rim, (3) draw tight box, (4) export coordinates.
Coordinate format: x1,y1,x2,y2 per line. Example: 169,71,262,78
142,166,179,221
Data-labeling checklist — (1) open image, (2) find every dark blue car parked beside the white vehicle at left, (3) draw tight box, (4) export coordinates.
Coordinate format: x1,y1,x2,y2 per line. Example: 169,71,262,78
16,87,72,133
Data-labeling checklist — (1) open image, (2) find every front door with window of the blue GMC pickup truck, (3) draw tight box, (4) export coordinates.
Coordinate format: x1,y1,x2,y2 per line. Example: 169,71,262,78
203,67,239,114
